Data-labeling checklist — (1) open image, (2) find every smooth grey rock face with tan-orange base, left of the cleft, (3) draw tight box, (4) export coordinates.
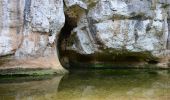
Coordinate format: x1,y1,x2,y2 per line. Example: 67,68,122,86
0,0,65,70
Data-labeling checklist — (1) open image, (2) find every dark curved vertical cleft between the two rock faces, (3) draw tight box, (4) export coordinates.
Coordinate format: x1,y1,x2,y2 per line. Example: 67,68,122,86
57,13,77,69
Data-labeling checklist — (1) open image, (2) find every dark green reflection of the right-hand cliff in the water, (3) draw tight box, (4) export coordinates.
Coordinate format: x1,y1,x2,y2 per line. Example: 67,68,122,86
55,69,170,100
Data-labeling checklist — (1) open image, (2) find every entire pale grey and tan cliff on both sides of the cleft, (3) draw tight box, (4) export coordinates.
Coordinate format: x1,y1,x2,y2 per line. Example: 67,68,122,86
0,0,170,70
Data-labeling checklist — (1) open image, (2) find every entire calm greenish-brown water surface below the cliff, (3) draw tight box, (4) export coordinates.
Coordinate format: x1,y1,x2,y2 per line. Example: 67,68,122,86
0,69,170,100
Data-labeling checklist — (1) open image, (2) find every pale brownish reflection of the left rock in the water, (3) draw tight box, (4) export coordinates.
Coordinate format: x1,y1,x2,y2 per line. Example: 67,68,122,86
0,76,63,100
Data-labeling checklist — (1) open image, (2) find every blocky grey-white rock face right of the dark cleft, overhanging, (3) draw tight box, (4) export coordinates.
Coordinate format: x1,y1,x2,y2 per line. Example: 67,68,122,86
62,0,170,67
